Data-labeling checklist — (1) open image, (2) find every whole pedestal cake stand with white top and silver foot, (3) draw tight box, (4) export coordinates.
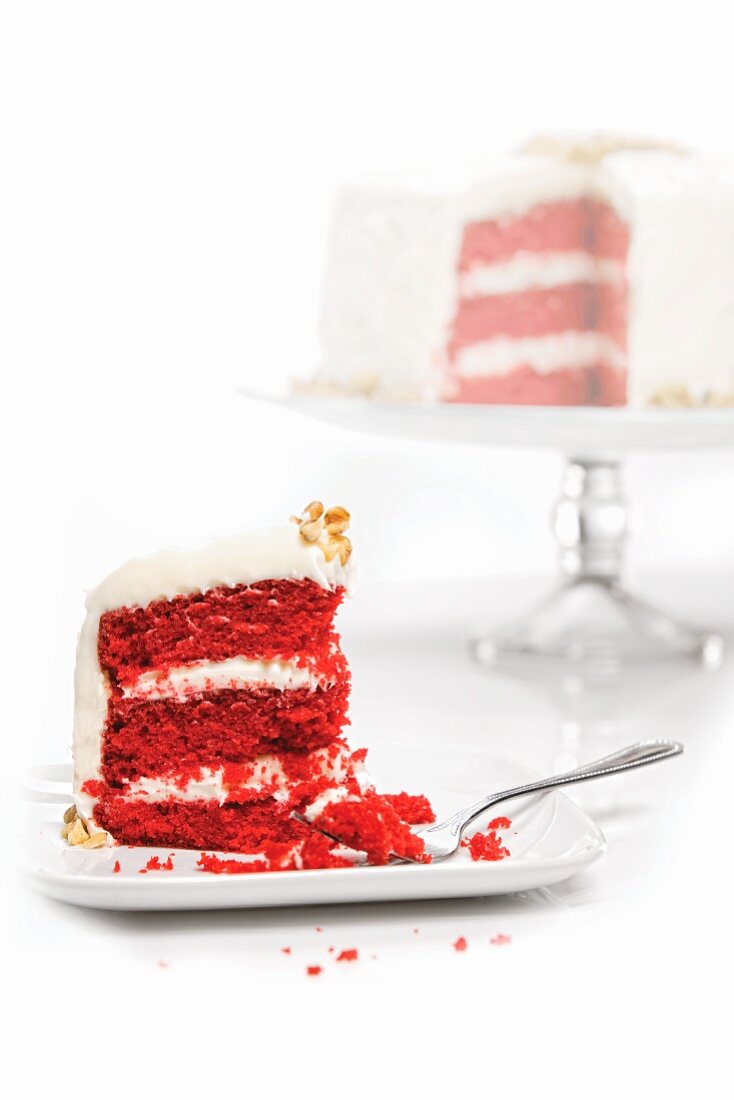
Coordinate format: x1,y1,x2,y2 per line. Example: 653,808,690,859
245,394,734,674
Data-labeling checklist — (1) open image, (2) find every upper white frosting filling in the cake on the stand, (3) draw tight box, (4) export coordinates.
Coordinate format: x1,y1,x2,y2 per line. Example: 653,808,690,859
458,252,624,298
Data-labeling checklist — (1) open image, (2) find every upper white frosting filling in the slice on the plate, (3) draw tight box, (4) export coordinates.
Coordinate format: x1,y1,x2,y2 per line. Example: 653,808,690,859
122,657,327,700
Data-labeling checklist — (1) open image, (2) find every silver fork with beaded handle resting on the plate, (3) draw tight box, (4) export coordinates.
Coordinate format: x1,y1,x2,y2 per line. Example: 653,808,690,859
402,741,683,862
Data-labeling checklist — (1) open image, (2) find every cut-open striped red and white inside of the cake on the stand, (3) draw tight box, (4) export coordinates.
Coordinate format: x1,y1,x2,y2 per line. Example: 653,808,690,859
445,156,629,405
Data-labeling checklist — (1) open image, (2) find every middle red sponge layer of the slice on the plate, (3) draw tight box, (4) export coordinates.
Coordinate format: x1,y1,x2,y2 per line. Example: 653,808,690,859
102,674,349,784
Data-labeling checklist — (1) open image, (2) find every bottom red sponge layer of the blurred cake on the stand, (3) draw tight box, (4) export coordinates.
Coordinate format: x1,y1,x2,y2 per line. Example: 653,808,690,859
445,364,627,405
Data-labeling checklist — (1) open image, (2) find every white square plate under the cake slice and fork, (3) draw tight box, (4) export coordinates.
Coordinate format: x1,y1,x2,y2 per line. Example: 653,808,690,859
19,745,605,910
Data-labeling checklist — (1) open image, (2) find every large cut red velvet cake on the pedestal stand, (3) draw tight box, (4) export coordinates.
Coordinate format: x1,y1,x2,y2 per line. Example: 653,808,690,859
308,134,734,407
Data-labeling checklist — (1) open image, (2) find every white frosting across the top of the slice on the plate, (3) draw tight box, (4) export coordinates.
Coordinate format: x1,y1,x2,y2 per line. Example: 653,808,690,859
87,523,354,617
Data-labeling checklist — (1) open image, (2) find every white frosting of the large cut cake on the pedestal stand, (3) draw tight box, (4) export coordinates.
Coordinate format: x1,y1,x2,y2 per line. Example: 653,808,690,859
318,141,734,406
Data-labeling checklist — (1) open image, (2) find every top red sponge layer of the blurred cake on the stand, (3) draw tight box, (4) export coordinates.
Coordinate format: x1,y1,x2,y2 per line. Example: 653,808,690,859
459,198,629,272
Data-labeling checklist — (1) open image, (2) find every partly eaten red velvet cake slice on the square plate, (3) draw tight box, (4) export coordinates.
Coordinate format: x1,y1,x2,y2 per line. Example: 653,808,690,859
64,502,431,870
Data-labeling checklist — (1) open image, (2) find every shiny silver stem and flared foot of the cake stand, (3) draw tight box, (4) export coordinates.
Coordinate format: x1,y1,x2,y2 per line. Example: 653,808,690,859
471,459,723,674
